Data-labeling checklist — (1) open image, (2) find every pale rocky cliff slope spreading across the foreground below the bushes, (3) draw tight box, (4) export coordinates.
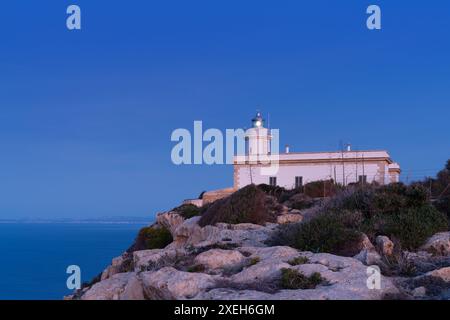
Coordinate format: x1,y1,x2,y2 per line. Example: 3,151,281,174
66,185,450,300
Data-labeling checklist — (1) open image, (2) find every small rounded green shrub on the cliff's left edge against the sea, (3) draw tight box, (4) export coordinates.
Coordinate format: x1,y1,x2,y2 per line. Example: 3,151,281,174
133,226,173,251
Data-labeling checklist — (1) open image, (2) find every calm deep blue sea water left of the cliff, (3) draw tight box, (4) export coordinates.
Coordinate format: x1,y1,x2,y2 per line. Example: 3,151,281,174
0,223,147,300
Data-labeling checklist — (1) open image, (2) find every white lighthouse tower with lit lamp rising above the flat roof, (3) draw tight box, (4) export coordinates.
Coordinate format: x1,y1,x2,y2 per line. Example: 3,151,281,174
245,112,272,160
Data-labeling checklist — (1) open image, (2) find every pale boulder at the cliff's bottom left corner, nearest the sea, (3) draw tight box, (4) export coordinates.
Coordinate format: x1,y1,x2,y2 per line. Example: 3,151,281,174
81,272,144,300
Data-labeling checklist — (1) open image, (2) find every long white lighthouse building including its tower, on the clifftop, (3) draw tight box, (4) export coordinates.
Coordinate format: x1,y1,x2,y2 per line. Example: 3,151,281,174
233,112,400,190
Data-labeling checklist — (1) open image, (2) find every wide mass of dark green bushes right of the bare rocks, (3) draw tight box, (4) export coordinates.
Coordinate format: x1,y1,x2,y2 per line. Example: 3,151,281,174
270,183,448,256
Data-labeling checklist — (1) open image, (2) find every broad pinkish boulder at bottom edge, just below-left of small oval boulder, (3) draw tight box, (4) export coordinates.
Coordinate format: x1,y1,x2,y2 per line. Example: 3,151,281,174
140,267,215,299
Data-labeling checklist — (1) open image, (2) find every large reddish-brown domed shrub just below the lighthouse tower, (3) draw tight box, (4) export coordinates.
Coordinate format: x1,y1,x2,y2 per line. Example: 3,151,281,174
199,185,276,227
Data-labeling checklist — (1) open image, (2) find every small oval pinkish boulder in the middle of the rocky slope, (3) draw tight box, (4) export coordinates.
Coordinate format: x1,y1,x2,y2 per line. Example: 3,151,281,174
194,249,245,270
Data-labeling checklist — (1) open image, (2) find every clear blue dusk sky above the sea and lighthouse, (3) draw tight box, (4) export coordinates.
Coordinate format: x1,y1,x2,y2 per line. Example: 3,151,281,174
0,0,450,218
